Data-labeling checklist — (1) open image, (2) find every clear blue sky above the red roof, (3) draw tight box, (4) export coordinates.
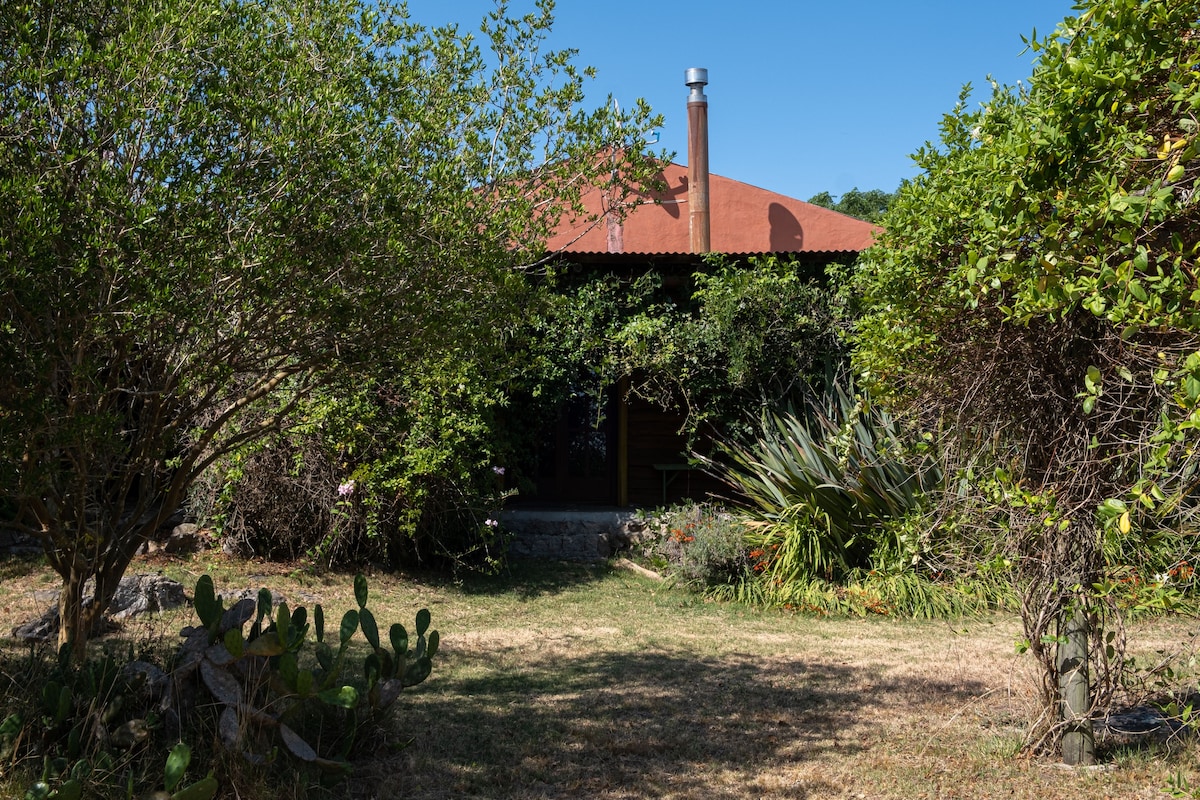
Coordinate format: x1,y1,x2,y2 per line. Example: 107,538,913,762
408,0,1074,200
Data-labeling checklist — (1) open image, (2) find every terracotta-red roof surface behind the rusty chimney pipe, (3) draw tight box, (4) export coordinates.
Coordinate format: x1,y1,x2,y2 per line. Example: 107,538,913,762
547,163,882,255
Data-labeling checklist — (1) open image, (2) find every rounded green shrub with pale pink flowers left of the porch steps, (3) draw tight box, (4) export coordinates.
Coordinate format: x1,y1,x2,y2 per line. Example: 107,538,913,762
205,354,522,570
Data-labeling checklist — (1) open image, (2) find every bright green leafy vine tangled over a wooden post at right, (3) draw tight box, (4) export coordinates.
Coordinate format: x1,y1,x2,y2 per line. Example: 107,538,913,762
856,0,1200,763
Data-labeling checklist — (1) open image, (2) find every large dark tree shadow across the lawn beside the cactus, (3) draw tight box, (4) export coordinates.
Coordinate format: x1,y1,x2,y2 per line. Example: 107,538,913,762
350,650,978,799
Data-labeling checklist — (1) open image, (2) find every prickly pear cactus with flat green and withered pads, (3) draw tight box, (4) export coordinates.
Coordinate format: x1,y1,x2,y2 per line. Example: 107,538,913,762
174,575,439,772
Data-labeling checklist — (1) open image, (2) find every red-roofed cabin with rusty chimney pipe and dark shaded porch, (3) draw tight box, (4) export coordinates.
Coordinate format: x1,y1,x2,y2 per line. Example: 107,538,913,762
506,70,880,558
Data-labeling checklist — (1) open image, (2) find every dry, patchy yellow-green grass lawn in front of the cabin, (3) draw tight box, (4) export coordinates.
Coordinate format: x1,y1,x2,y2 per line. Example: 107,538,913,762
0,555,1200,800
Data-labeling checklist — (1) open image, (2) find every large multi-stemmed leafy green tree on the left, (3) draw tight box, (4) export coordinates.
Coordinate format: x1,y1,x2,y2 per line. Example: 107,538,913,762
0,0,649,651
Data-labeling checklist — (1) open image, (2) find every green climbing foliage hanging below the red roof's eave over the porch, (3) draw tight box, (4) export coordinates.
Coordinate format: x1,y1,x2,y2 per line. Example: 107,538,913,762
530,257,845,437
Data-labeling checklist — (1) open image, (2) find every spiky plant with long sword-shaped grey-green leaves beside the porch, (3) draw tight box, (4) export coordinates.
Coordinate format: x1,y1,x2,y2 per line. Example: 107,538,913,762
708,381,942,585
